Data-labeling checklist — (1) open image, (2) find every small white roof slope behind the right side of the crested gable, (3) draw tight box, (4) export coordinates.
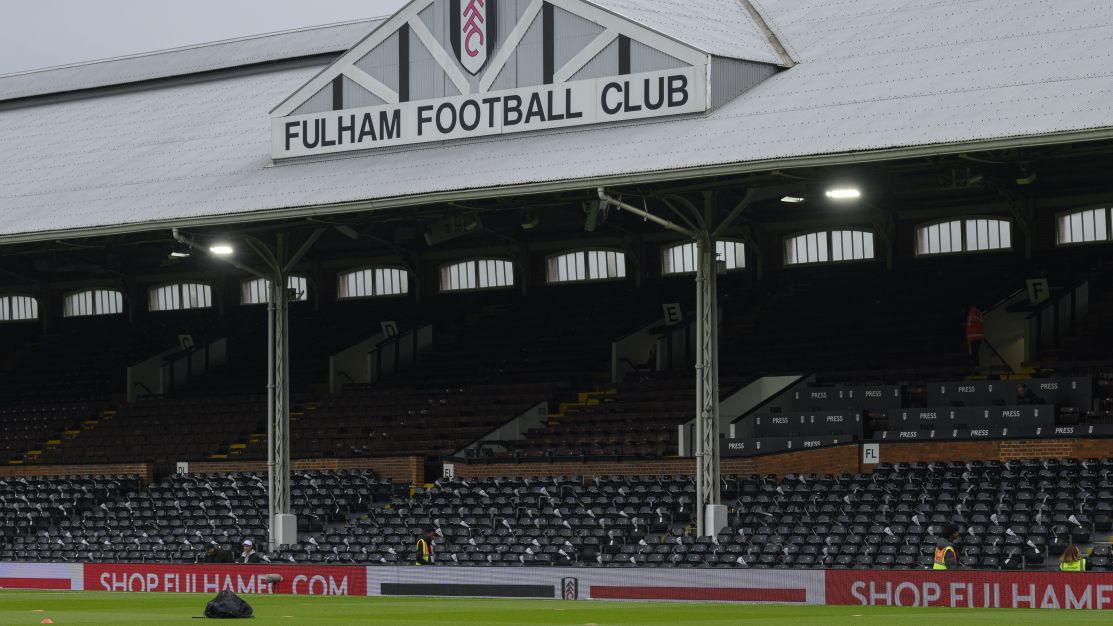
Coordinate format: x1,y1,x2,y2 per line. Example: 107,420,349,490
588,0,785,66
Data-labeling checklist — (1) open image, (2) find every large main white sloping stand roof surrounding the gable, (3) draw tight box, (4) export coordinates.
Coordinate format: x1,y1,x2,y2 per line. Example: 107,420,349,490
0,0,1113,243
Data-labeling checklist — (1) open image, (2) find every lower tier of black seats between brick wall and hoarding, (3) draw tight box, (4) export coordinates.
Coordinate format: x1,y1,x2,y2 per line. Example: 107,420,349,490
0,459,1113,571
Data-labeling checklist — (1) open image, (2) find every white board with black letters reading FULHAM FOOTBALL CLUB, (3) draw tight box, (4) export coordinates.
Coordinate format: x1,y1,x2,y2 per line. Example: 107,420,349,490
270,66,708,159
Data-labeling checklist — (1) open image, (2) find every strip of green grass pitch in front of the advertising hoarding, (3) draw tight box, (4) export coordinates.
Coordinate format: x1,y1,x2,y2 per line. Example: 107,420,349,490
0,590,1110,626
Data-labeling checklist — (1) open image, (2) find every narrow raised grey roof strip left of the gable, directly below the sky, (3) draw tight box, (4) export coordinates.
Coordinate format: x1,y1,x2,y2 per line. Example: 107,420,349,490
0,19,382,100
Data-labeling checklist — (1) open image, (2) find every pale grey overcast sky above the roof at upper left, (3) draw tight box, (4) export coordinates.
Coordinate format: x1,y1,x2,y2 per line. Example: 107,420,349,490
0,0,405,74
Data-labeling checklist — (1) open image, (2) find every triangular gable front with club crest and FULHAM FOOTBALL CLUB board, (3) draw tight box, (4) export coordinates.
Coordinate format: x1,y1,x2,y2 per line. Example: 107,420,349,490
270,0,737,159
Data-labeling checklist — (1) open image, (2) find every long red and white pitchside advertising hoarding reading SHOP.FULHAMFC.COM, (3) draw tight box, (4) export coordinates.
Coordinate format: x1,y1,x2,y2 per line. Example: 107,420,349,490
0,563,1113,610
